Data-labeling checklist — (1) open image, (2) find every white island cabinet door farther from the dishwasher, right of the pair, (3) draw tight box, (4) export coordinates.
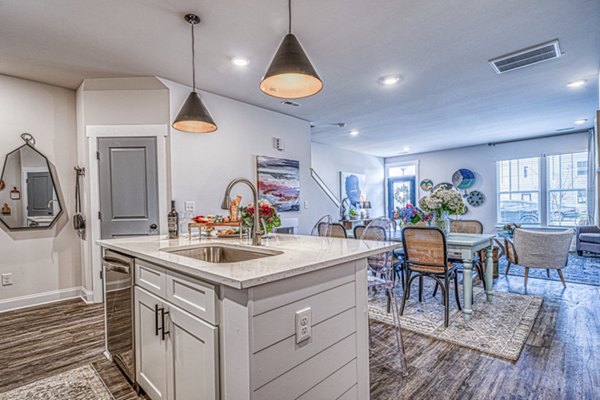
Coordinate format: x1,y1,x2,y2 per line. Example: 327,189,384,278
167,306,219,400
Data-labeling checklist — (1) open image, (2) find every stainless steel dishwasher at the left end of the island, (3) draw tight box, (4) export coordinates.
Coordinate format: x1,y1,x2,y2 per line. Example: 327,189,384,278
102,250,138,390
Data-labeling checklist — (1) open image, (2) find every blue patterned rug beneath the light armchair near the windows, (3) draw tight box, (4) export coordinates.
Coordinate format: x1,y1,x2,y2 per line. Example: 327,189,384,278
498,253,600,286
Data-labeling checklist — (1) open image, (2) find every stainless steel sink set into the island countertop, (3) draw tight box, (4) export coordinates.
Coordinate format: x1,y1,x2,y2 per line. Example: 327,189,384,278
163,244,283,263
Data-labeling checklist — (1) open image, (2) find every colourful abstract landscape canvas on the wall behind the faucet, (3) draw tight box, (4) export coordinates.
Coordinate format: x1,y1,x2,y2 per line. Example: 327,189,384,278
256,156,300,212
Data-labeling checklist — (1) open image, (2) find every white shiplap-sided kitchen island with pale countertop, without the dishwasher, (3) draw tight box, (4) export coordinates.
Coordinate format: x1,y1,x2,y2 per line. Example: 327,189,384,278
99,235,399,400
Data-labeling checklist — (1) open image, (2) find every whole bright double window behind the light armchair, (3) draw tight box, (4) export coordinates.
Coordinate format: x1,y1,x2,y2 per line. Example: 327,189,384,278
496,152,587,226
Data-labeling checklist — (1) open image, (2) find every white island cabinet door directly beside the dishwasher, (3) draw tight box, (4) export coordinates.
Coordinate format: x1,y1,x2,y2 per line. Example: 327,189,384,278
135,287,168,400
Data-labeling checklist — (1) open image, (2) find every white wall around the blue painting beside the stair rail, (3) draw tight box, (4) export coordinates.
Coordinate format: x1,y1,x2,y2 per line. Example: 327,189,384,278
311,142,385,218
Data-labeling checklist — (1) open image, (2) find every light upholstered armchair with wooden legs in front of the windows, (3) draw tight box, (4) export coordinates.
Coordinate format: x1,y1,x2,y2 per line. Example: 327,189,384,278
505,229,574,287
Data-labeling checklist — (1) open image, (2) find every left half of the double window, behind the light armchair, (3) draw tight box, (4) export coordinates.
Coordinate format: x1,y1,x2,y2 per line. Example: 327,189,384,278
496,157,541,225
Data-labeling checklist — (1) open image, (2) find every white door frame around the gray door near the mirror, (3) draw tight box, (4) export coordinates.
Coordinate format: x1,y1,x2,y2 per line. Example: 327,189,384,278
82,124,169,303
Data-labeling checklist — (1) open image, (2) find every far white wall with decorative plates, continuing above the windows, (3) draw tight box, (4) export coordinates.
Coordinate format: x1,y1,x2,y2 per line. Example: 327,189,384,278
385,133,587,232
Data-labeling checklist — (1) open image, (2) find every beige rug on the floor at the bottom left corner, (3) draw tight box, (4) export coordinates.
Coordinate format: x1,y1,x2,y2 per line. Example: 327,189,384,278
0,364,114,400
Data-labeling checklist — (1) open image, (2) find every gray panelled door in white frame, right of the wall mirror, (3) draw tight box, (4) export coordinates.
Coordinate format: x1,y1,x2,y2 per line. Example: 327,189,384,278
98,137,159,239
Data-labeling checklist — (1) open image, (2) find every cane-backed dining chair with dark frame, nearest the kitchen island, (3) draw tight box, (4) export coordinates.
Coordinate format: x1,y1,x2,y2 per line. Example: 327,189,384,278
400,226,462,327
